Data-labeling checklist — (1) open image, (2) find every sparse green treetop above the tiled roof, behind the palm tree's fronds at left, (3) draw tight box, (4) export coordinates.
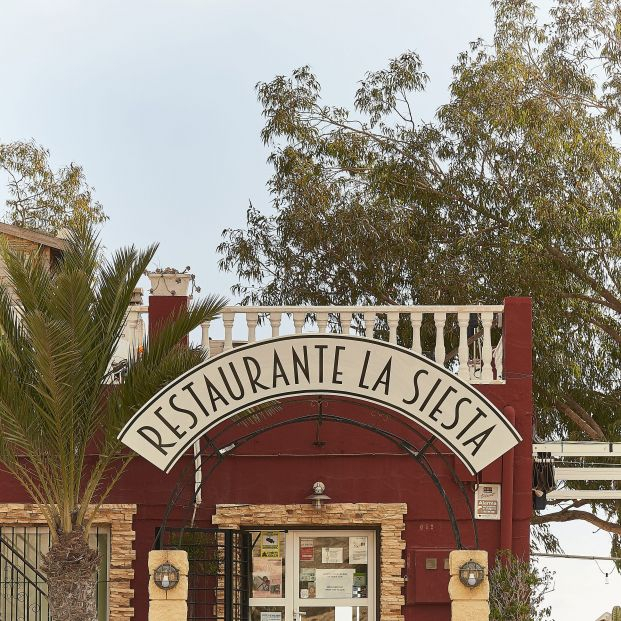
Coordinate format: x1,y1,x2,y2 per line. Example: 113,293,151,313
0,141,107,234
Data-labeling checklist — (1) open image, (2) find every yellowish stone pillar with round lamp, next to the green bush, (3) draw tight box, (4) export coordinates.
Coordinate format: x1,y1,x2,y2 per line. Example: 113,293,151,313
449,550,489,621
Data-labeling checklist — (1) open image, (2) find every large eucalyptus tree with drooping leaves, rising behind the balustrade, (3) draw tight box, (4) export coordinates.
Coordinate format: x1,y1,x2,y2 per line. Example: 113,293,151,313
219,0,621,552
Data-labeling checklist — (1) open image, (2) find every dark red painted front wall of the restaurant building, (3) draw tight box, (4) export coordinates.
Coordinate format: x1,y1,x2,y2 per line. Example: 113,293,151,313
0,297,533,621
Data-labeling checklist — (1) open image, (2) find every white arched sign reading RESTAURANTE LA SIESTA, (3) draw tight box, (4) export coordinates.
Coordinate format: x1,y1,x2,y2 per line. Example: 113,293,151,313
119,334,521,473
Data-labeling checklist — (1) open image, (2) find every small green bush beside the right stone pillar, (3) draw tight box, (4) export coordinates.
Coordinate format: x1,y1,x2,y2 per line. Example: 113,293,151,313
489,550,554,621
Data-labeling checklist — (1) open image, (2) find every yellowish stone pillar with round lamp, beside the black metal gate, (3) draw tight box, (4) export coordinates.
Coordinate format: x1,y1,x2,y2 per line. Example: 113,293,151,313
149,550,189,621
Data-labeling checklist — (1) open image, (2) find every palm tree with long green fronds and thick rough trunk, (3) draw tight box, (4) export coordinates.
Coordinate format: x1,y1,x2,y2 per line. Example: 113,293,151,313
0,225,225,621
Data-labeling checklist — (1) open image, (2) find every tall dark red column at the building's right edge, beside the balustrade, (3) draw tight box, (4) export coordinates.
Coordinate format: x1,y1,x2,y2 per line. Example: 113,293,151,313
503,298,533,559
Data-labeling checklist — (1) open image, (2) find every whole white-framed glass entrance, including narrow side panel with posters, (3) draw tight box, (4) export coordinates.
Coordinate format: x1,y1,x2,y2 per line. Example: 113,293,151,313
250,530,376,621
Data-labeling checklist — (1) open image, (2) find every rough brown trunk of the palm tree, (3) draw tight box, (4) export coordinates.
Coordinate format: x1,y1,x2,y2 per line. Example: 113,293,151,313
43,530,99,621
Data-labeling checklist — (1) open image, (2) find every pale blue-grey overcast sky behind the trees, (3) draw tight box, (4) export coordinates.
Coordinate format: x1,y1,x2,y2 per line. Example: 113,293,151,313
0,0,621,621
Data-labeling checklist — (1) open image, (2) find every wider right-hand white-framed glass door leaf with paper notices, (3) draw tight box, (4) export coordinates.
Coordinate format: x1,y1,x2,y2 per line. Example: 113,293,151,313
293,530,375,621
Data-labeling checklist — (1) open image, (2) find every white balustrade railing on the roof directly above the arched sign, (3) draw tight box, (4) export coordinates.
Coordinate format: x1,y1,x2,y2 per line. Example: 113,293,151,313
202,305,504,384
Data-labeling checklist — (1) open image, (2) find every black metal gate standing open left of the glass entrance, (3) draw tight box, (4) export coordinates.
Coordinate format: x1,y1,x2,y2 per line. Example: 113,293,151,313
161,528,250,621
